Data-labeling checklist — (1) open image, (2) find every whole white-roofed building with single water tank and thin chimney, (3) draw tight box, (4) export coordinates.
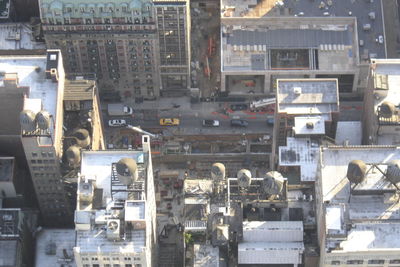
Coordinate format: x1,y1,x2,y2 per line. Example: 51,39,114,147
74,136,157,267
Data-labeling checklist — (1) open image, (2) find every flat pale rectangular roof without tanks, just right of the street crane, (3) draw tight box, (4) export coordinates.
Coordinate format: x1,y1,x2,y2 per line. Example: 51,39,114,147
276,79,339,115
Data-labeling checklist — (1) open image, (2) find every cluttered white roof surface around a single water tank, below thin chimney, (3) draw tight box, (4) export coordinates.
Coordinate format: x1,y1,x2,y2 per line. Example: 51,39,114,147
75,150,148,253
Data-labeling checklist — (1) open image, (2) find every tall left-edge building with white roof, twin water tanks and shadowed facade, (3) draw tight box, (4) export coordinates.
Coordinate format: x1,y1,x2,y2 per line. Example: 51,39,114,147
0,50,72,225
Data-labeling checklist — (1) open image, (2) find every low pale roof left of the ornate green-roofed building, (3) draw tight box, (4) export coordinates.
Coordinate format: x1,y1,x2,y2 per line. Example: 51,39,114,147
0,23,46,50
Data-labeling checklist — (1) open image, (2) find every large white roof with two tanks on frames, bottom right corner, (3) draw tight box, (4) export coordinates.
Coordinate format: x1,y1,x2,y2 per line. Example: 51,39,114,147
316,146,400,251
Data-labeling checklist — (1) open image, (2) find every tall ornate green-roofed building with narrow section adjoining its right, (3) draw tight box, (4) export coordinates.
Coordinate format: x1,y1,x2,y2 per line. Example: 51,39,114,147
39,0,190,98
